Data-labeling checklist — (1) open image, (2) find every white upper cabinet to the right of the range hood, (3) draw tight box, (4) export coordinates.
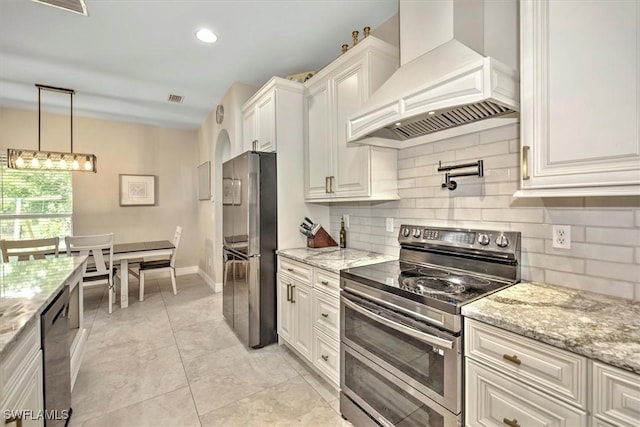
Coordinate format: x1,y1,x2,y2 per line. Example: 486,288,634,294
516,0,640,197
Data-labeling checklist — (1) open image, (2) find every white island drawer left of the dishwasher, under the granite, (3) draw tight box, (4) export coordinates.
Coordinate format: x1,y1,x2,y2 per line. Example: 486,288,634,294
0,319,40,391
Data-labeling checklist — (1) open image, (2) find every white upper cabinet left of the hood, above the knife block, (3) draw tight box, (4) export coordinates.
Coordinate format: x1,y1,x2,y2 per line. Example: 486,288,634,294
304,37,398,202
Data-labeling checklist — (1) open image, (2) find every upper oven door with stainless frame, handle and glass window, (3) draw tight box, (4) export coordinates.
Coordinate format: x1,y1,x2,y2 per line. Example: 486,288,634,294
341,292,462,414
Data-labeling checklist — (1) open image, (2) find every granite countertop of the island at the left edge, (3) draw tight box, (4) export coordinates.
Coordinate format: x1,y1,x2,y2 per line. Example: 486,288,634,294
0,256,86,360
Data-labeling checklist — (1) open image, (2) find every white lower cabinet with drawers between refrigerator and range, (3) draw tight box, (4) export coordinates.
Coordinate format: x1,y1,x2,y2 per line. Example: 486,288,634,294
277,256,340,388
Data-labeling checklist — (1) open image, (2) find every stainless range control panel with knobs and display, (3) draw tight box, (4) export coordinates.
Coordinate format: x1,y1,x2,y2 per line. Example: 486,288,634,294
398,225,520,253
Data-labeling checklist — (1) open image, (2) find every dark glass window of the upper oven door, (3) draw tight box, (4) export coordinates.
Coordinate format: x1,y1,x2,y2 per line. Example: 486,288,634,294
344,300,445,396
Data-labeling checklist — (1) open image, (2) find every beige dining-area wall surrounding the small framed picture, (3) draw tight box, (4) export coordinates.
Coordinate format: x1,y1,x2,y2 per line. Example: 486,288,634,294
0,108,200,267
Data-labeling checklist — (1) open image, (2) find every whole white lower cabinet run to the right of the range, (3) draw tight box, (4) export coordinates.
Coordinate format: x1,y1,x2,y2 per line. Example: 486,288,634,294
464,318,640,427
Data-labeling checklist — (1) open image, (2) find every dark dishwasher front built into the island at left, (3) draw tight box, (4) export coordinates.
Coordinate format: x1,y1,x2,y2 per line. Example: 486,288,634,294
40,286,71,427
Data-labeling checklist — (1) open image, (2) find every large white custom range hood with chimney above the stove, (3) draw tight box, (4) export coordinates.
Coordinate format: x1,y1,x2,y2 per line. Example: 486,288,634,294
347,0,520,148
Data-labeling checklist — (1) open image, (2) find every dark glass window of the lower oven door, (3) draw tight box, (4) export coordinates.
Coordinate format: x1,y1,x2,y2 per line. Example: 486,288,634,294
344,352,445,427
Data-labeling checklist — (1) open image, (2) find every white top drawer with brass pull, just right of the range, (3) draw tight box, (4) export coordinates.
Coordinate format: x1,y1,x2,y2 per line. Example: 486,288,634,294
465,319,587,409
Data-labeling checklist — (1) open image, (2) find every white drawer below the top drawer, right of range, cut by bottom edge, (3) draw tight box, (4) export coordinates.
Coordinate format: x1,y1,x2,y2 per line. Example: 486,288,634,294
465,359,588,427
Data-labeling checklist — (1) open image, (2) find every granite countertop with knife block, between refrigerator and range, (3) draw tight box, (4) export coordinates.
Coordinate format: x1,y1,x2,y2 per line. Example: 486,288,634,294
276,246,398,273
